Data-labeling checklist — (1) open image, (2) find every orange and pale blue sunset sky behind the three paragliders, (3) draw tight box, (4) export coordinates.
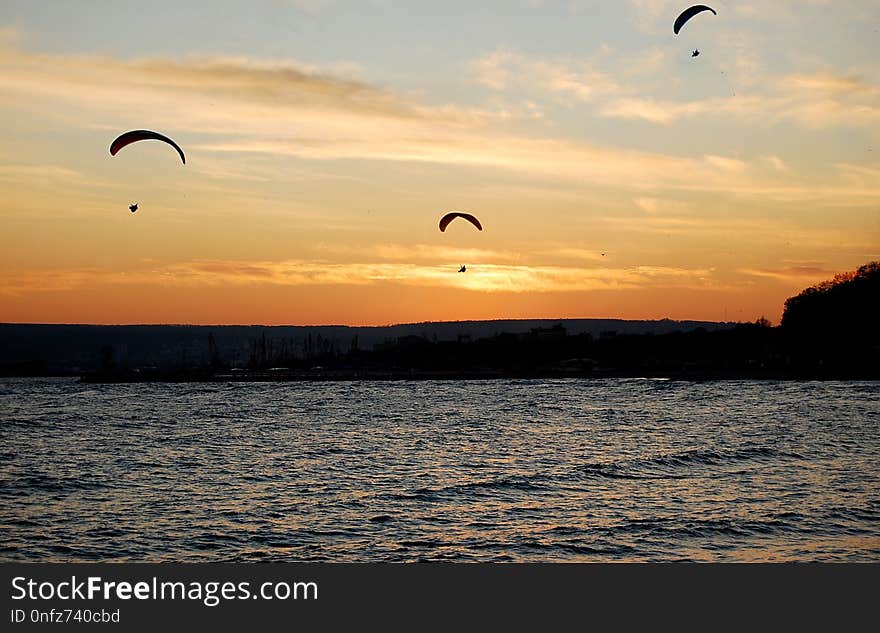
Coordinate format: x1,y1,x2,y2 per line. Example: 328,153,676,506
0,0,880,325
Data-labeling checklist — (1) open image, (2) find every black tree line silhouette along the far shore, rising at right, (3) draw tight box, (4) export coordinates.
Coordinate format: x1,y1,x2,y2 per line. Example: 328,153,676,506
77,262,880,380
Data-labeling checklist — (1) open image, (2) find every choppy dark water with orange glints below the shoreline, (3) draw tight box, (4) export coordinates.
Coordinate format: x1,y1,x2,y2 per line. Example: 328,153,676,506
0,379,880,561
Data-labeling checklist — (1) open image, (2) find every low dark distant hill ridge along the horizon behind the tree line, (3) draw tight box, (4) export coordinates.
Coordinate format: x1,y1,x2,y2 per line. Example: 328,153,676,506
0,319,734,375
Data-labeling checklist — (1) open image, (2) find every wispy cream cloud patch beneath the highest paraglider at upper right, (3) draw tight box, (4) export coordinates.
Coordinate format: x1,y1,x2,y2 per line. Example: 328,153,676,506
470,23,880,135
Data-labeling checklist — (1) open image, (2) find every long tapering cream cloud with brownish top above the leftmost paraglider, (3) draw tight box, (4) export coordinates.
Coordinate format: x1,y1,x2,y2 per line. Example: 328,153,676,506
0,50,456,120
